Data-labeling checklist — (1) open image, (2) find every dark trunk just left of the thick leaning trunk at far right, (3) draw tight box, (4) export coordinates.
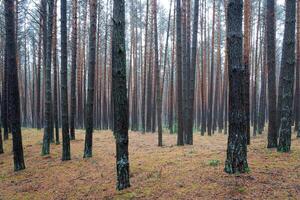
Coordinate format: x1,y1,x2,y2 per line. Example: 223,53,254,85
266,0,277,148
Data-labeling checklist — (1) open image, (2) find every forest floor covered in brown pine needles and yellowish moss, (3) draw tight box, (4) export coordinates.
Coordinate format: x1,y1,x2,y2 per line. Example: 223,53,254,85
0,129,300,200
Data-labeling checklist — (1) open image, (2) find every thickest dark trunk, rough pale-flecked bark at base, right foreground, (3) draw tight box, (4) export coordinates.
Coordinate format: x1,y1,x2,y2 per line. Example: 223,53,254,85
225,0,248,174
